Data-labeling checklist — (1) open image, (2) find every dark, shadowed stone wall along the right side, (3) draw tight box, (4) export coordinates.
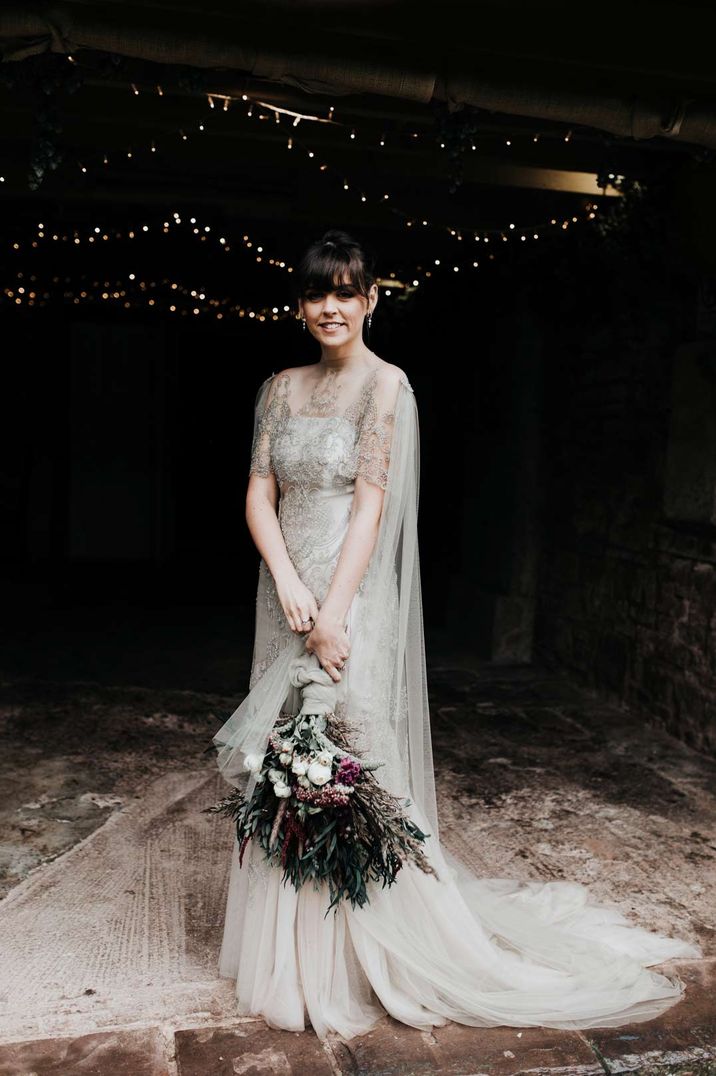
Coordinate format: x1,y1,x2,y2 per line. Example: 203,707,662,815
534,281,716,753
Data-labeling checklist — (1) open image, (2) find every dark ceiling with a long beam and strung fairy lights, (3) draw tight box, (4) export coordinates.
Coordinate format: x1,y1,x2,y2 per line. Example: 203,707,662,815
0,0,716,286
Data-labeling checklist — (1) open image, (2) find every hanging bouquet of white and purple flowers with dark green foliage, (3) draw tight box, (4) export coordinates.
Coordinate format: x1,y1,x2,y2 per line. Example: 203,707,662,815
205,649,438,915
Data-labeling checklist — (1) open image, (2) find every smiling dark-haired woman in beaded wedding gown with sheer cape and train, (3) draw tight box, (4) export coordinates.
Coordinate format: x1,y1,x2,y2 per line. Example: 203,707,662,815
214,231,702,1038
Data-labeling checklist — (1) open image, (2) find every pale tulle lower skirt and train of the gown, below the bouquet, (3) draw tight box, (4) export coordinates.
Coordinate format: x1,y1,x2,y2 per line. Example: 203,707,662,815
220,804,701,1038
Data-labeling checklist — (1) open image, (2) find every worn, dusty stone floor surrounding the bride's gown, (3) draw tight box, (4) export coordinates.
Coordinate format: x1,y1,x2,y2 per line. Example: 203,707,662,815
0,607,716,1076
